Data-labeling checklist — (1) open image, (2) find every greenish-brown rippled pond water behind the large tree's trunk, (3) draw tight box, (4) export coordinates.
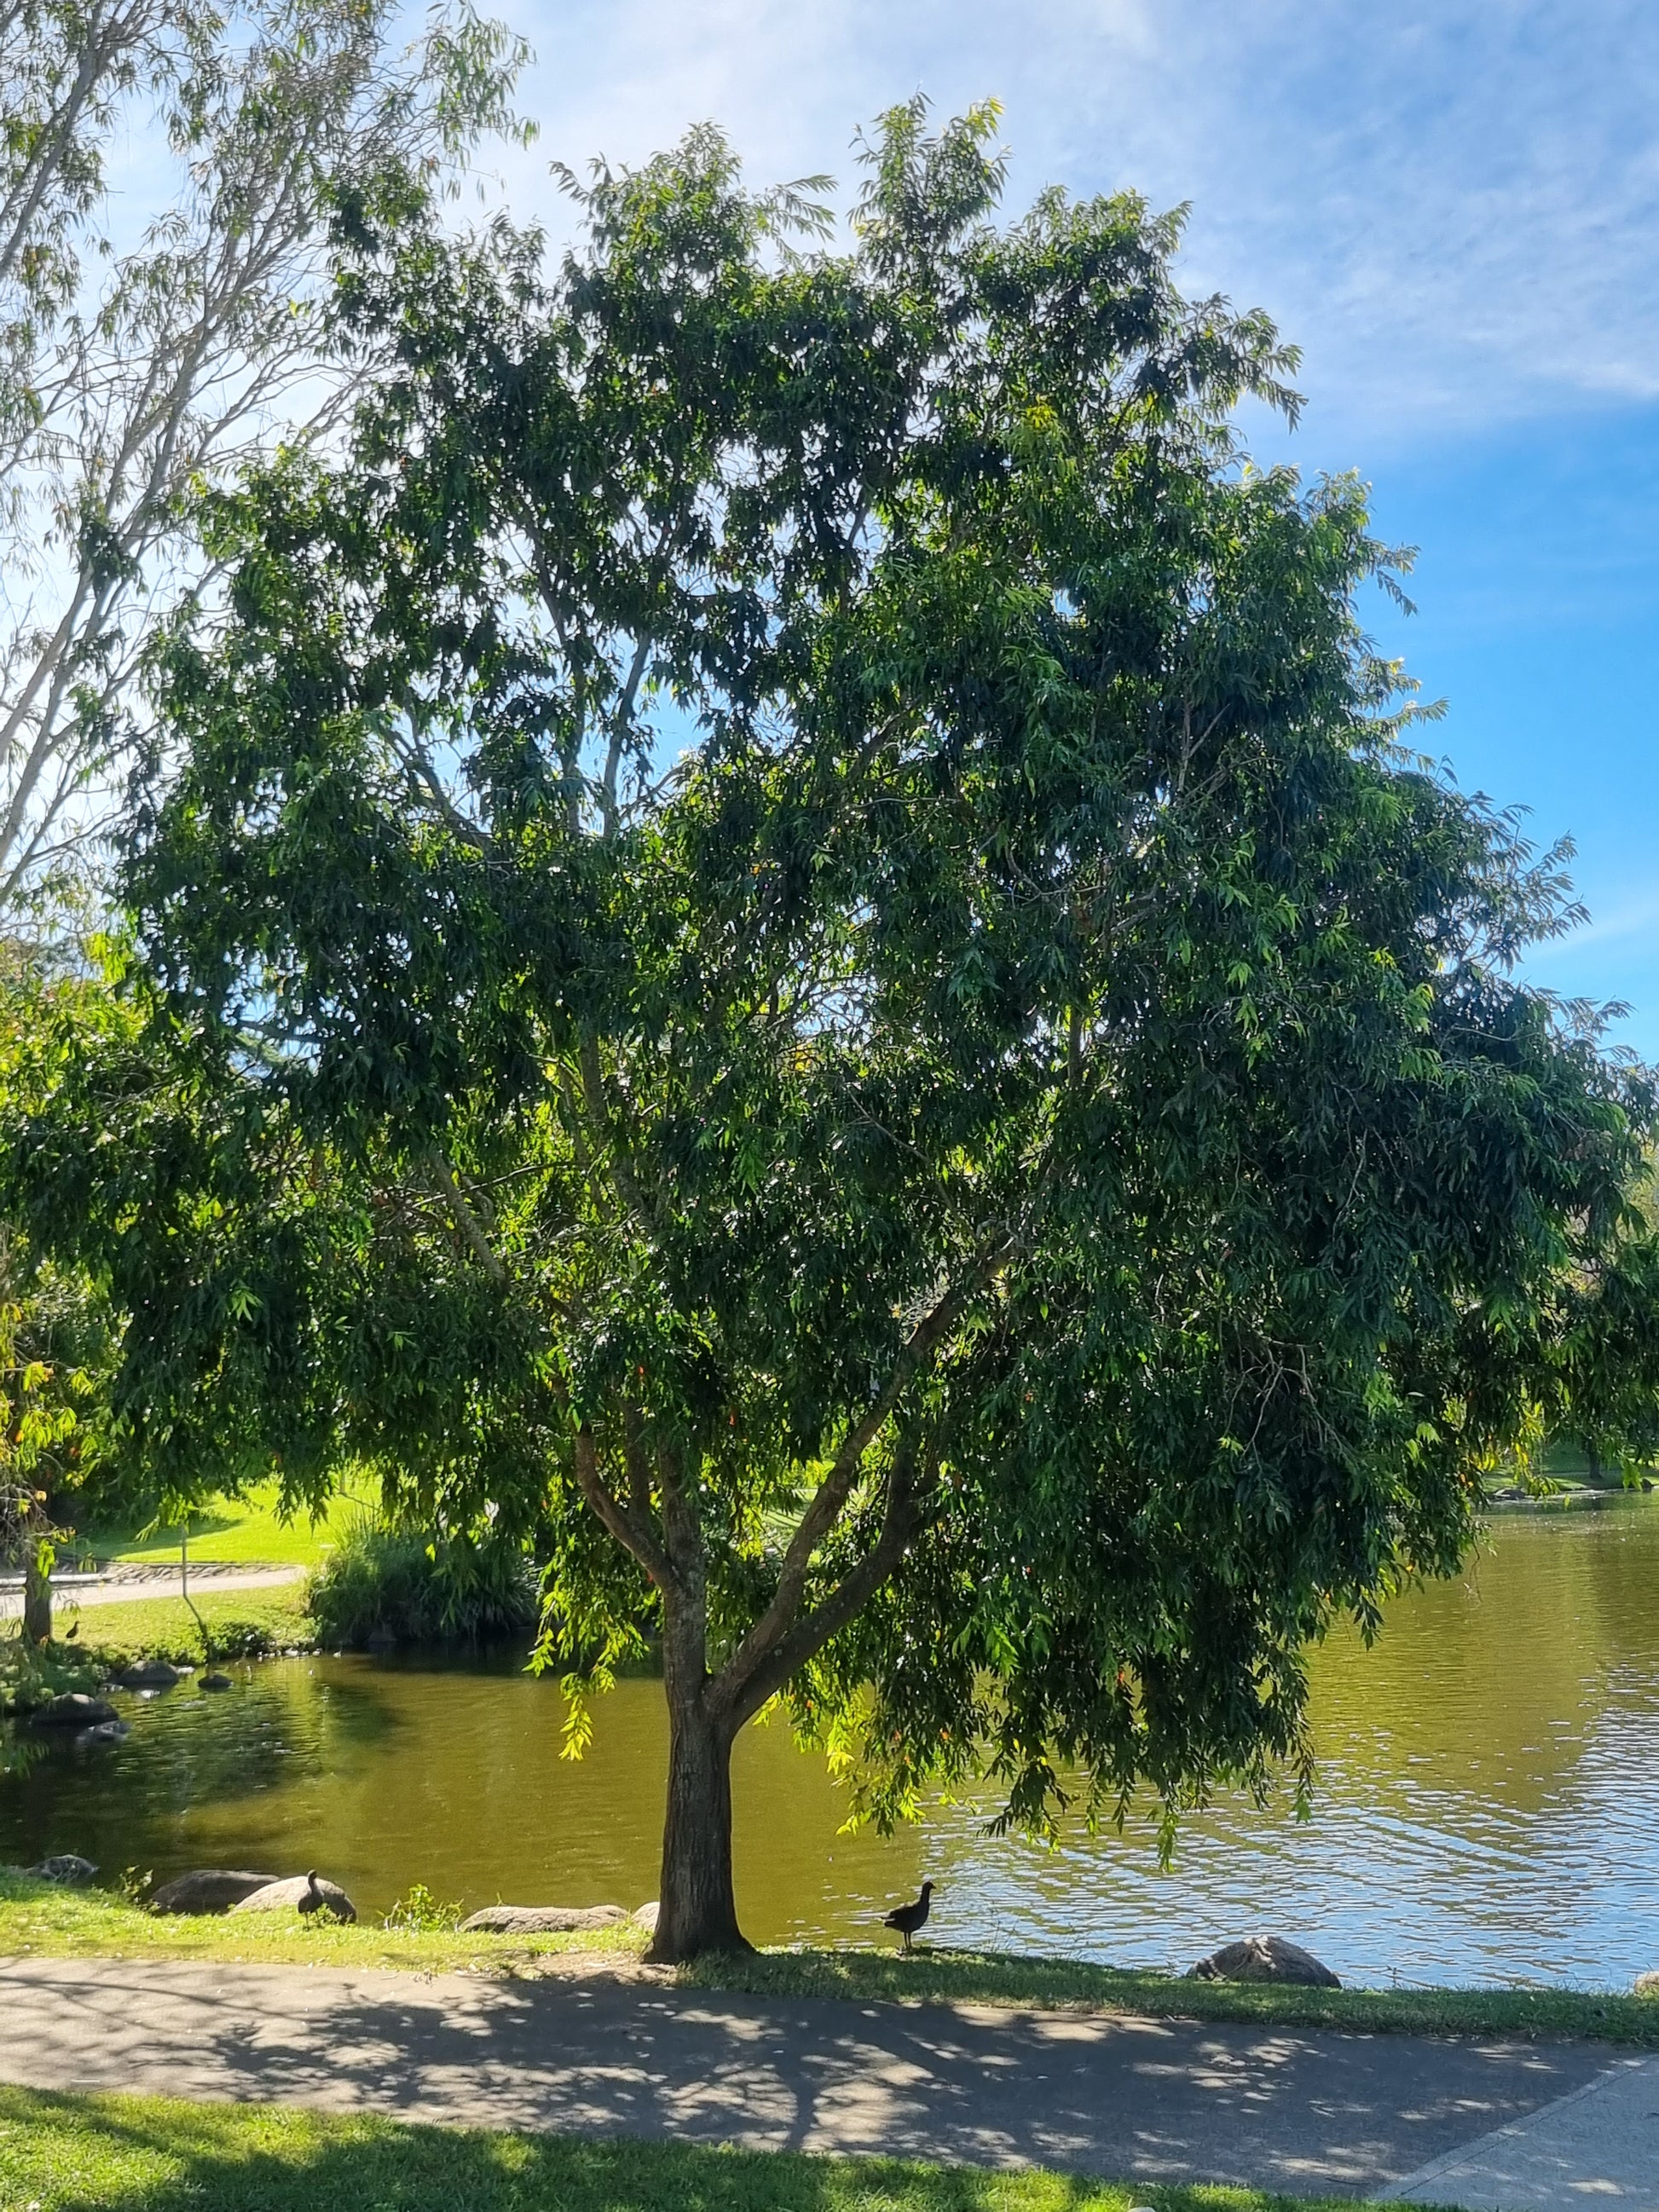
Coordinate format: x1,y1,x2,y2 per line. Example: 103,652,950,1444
0,1499,1659,1984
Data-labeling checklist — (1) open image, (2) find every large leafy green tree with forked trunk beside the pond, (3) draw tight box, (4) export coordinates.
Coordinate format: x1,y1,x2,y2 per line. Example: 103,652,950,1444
11,108,1648,1960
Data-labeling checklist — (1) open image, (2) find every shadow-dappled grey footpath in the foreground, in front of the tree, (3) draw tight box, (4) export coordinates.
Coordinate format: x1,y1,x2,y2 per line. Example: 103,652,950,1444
0,1958,1659,2212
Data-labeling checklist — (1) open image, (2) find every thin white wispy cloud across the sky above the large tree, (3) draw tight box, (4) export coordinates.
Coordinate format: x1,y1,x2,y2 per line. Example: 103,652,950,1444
493,0,1659,451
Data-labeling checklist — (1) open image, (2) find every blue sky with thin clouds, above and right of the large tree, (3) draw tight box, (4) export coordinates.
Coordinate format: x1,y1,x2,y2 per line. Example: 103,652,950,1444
480,0,1659,1057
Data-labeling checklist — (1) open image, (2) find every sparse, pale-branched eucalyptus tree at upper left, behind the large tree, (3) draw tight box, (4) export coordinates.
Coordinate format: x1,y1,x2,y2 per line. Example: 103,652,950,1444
0,0,520,903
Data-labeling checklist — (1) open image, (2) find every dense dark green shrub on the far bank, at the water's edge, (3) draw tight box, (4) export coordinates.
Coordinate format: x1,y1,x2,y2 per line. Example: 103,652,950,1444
305,1520,540,1648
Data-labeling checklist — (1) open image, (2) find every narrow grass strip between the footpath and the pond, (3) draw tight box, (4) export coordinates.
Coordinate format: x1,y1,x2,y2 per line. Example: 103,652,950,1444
0,1869,1659,2051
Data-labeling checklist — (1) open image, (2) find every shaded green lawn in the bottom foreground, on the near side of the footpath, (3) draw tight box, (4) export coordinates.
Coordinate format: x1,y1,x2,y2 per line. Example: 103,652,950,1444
0,2088,1415,2212
